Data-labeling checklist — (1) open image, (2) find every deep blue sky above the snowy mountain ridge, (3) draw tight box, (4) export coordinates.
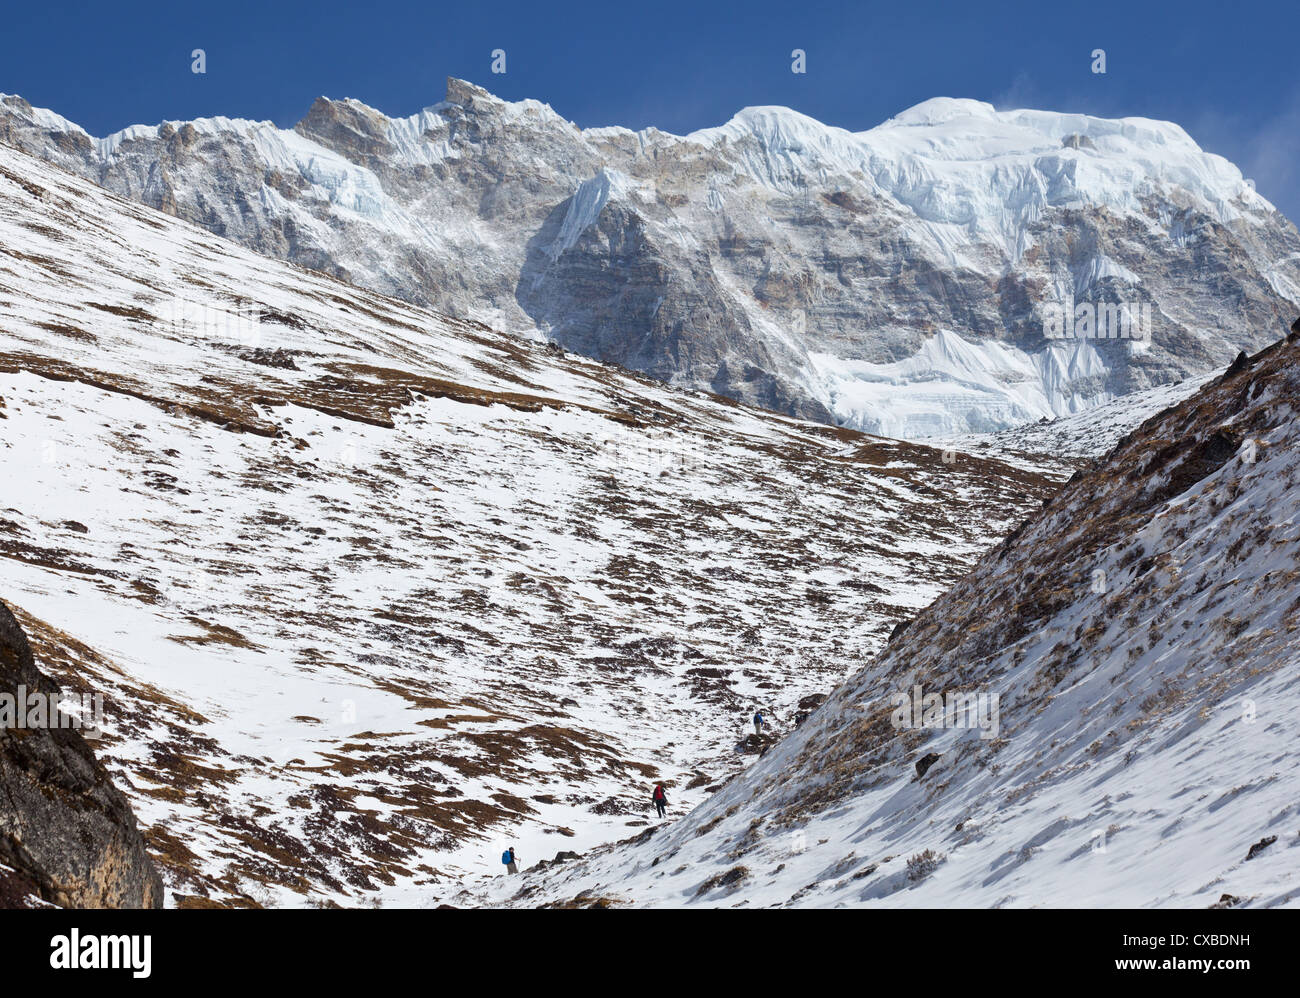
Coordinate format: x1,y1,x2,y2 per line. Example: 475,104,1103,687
0,0,1300,220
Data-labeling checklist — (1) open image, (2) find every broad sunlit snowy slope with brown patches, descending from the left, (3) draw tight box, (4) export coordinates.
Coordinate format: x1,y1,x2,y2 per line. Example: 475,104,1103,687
0,136,1054,904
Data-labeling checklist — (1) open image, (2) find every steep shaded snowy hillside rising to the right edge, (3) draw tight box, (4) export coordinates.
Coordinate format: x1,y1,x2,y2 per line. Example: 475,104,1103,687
465,331,1300,907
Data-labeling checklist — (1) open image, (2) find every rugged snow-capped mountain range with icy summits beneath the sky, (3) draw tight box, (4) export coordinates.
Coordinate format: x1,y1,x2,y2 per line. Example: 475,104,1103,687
0,79,1300,438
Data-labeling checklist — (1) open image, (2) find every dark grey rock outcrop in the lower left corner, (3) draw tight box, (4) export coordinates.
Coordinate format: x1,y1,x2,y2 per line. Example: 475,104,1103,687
0,603,163,908
